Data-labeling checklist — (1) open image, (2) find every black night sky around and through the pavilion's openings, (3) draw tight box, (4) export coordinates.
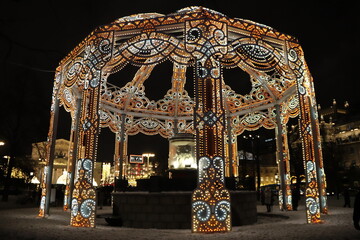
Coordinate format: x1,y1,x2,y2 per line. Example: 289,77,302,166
0,0,360,163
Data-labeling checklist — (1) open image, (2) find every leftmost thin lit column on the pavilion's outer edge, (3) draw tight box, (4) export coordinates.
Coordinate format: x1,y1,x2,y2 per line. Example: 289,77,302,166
39,67,61,217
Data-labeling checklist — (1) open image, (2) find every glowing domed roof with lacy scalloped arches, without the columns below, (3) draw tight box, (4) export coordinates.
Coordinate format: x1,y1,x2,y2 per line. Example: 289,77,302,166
60,6,304,138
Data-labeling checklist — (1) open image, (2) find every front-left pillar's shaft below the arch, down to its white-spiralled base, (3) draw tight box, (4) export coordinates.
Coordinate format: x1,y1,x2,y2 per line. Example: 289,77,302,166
70,86,100,227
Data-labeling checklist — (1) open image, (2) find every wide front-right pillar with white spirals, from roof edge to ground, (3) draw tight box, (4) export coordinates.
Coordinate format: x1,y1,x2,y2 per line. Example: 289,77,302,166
287,42,326,223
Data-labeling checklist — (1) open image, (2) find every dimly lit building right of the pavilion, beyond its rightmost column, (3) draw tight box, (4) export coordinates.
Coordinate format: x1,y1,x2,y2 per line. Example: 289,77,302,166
319,100,360,189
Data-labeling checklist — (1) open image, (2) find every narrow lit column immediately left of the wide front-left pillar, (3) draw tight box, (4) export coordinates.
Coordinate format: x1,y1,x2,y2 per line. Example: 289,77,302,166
64,98,81,211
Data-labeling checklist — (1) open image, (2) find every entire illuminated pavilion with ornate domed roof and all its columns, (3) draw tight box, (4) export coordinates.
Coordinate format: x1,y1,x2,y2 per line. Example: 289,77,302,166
39,7,327,232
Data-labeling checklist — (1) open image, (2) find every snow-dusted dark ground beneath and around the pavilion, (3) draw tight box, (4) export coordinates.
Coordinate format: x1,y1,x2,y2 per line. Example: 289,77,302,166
0,197,360,240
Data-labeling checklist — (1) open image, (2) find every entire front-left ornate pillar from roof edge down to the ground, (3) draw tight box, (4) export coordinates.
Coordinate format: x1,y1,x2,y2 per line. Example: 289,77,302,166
68,32,112,227
